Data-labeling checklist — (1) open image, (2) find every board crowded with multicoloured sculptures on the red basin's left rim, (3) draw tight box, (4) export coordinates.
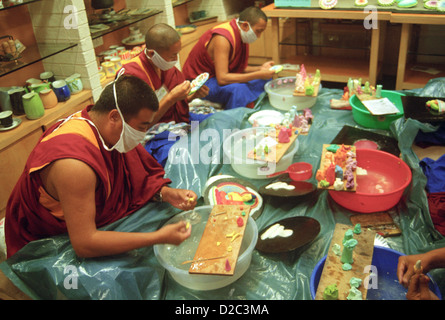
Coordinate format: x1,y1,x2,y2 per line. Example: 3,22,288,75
315,144,357,192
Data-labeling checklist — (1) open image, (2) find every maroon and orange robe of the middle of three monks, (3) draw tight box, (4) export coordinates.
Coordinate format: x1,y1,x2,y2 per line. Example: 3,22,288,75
122,52,190,123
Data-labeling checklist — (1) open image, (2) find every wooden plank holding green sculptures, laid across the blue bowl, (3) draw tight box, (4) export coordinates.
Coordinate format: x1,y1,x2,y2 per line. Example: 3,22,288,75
315,224,375,300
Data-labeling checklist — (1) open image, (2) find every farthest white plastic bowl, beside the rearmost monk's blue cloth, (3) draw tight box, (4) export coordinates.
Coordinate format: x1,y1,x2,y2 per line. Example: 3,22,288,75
264,77,317,110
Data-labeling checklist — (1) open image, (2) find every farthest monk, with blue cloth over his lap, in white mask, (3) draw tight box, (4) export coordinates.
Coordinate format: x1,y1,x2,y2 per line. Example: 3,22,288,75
183,7,275,109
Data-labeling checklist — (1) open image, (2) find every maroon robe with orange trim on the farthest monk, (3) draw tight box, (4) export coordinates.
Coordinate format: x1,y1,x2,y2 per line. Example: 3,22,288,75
182,19,249,80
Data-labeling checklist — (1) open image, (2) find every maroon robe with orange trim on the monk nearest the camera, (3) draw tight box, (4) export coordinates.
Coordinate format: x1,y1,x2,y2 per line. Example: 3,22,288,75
5,106,171,258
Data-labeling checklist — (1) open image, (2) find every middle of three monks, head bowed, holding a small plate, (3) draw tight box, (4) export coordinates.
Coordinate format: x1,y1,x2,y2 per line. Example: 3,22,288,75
120,23,209,166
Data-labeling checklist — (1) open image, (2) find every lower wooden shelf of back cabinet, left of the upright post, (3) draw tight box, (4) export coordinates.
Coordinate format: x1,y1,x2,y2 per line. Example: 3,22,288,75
279,55,378,83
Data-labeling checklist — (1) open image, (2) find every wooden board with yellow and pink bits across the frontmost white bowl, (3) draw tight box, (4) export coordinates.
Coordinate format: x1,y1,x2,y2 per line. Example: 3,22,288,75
189,205,250,276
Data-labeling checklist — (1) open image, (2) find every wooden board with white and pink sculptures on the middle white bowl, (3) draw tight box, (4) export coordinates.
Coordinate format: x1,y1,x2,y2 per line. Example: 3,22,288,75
247,128,300,163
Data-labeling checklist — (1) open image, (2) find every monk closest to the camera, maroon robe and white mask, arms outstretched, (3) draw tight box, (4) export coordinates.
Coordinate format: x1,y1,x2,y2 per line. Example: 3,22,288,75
5,75,196,257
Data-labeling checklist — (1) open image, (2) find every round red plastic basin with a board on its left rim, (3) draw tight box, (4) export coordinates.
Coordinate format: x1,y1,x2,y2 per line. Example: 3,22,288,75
329,149,412,213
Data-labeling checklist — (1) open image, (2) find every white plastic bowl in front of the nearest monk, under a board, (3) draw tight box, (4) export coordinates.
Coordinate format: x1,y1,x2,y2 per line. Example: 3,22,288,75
153,206,258,291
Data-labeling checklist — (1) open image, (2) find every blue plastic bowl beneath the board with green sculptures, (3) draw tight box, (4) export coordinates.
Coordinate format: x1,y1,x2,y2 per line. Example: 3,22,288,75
310,246,442,300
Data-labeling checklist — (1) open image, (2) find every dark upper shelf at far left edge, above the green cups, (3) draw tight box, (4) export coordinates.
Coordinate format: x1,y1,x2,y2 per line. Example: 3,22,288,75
0,43,77,77
